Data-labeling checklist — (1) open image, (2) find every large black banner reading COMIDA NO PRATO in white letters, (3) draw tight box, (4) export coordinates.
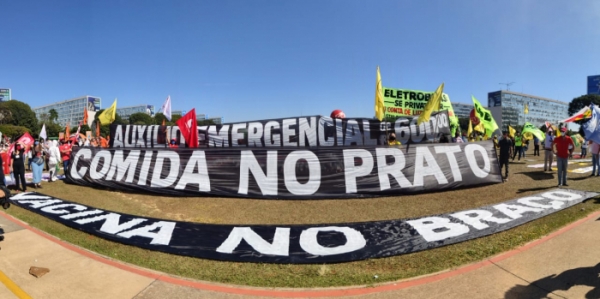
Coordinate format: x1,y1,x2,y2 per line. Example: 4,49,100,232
67,141,502,199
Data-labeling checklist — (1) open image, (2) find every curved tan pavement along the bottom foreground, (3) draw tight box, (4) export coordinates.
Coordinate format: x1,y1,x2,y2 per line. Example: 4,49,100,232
0,212,600,299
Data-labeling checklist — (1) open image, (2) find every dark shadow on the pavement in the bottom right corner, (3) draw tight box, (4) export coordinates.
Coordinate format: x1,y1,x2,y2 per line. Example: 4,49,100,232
504,263,600,298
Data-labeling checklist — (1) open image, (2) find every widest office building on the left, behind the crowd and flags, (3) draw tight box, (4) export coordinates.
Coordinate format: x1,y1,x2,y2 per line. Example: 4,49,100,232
32,96,102,126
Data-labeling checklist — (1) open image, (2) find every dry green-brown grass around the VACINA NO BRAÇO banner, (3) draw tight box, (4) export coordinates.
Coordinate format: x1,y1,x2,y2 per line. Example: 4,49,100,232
2,150,600,288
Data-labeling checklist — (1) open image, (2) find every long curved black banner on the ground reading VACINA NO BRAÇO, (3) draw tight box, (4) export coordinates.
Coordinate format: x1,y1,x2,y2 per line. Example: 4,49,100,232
11,189,598,264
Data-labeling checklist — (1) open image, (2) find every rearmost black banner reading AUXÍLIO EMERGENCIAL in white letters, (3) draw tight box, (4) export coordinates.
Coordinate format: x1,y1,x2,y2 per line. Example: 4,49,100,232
109,111,450,148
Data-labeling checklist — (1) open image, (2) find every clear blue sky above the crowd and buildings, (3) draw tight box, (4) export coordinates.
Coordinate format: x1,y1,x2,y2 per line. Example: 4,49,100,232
0,0,600,122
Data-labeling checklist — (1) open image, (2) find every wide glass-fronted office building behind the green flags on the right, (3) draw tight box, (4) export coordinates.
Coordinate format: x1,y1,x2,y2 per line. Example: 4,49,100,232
488,90,569,130
